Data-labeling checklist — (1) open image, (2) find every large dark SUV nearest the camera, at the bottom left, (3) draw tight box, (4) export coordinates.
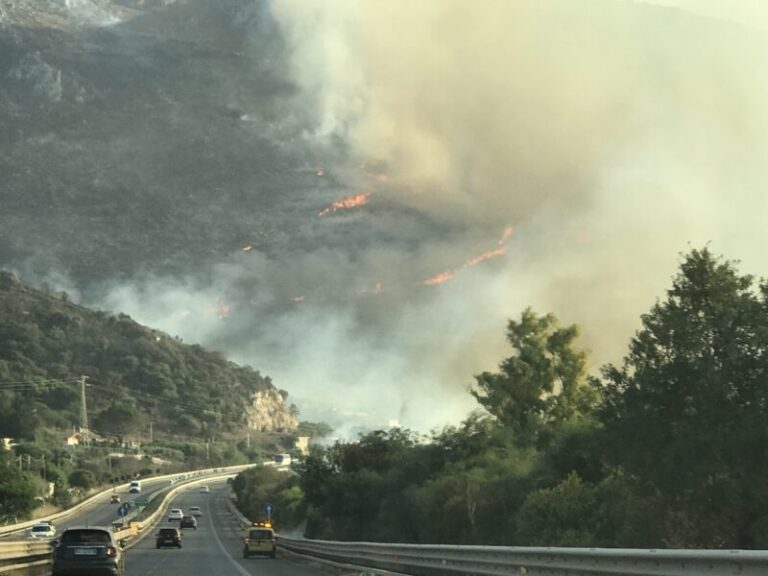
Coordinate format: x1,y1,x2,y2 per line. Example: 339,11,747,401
52,526,125,576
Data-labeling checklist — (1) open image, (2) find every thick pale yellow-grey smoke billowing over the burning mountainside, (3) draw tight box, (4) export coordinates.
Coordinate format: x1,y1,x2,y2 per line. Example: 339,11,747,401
99,0,768,429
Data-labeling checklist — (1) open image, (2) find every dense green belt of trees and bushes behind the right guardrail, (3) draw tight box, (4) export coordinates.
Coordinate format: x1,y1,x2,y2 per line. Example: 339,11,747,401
238,249,768,548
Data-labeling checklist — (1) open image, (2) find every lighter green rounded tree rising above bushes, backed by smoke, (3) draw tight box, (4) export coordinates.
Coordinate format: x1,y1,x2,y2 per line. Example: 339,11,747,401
471,308,595,442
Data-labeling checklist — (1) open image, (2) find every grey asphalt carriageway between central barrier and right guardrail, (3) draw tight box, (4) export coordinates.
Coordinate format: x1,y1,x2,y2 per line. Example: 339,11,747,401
125,481,321,576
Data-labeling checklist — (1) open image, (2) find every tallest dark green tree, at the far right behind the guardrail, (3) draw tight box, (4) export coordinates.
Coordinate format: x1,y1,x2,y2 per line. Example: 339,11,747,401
600,249,768,548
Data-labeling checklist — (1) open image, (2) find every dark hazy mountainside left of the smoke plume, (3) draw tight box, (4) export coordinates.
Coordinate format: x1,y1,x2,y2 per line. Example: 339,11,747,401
0,0,340,287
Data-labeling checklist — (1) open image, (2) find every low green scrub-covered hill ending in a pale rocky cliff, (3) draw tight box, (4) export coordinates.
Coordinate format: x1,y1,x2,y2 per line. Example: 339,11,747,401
0,272,295,439
